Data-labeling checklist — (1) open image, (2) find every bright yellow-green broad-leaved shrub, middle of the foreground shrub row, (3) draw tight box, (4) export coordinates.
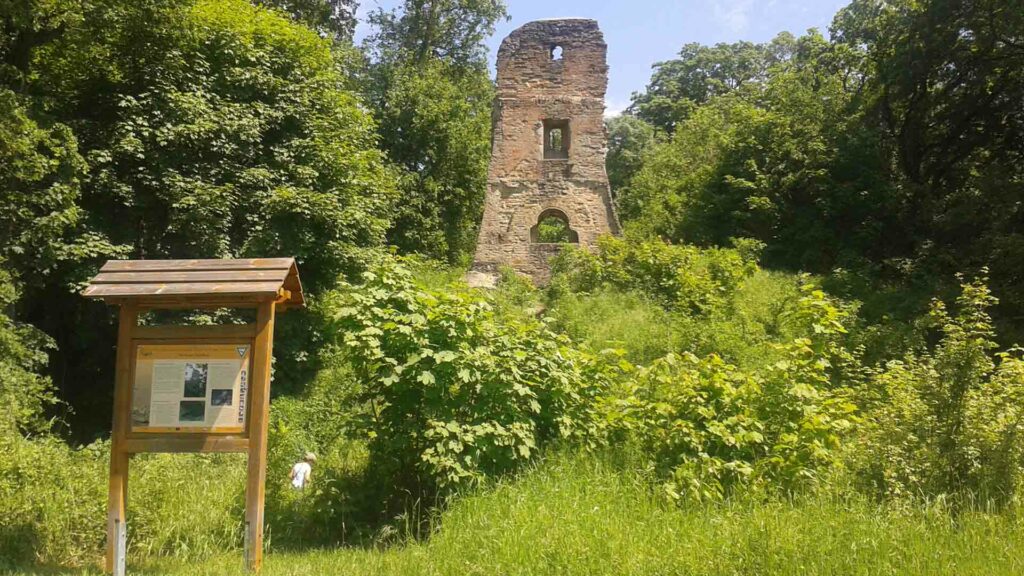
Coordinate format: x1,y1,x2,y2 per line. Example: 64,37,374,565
611,280,860,500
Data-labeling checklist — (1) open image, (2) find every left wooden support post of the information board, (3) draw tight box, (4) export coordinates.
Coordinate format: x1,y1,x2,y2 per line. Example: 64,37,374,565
106,303,138,576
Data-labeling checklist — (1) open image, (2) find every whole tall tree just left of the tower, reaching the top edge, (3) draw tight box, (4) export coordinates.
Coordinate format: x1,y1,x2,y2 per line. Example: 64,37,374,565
365,0,506,262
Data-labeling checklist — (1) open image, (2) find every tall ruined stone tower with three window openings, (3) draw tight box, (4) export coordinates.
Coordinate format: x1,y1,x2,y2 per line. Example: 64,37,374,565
473,18,618,283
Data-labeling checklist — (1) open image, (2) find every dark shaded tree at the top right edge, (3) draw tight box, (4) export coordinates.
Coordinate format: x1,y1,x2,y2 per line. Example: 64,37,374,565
833,0,1024,336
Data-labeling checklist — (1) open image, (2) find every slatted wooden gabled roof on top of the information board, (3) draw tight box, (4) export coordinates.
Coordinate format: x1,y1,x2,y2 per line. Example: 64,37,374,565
82,258,304,307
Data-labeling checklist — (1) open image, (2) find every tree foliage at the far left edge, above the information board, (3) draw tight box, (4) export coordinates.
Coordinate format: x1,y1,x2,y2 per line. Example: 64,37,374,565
0,0,114,290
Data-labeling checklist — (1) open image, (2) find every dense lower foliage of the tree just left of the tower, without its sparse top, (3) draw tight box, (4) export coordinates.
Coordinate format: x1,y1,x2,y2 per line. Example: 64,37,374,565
376,59,494,262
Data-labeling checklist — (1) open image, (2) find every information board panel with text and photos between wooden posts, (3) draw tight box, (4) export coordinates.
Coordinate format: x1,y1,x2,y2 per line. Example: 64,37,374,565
131,342,252,434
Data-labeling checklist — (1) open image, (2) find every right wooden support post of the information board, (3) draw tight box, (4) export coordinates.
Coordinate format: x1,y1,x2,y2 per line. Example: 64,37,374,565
246,301,274,571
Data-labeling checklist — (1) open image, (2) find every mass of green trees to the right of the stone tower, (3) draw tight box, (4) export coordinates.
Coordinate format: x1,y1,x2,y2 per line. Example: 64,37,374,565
616,0,1024,334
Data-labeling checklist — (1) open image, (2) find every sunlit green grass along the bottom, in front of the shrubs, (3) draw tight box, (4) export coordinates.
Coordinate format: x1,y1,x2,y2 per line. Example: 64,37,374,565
15,455,1024,576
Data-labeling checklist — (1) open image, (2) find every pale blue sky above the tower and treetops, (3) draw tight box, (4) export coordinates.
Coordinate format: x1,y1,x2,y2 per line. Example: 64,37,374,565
356,0,850,114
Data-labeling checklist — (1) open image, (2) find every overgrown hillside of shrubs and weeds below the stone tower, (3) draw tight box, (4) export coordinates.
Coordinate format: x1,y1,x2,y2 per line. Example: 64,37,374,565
0,239,1024,572
